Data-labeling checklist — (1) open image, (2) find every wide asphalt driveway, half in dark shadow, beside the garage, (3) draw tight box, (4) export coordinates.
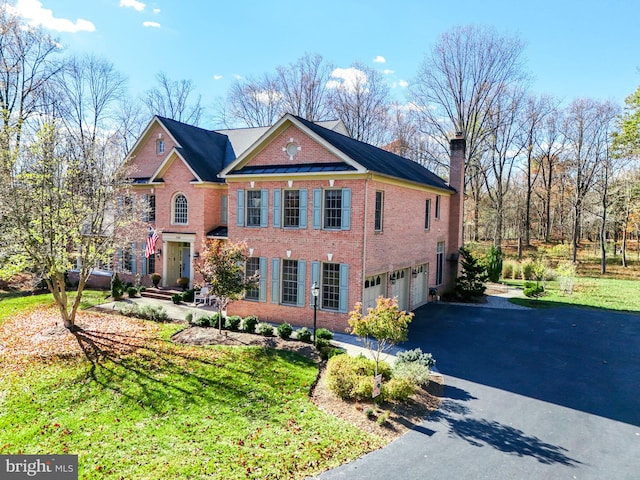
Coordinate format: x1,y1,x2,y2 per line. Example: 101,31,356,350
319,303,640,480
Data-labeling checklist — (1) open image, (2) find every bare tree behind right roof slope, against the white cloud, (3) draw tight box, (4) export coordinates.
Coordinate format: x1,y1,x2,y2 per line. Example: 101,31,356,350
327,62,390,145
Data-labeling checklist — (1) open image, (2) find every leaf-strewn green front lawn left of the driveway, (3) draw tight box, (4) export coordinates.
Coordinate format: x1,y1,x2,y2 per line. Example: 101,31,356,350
0,297,381,479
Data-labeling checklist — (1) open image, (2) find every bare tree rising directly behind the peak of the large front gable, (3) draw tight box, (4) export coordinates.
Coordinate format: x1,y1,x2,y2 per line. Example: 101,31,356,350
276,53,333,122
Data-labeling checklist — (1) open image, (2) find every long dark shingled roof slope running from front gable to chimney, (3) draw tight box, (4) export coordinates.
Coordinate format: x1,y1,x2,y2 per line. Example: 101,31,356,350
294,116,455,191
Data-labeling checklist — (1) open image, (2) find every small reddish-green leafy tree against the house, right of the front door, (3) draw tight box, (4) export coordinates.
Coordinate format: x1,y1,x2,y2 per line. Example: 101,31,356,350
196,240,258,332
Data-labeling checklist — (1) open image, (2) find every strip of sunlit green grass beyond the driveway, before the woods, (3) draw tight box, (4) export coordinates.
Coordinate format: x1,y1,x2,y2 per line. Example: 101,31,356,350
505,277,640,312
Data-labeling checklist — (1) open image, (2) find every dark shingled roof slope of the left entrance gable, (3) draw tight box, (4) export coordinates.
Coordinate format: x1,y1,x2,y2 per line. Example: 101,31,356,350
156,116,235,183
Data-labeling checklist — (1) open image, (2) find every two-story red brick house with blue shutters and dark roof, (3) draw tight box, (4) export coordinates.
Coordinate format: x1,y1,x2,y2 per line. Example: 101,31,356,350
120,115,464,329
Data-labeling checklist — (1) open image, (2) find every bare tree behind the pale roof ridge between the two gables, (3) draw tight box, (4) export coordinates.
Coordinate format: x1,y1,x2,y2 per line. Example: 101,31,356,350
226,74,284,127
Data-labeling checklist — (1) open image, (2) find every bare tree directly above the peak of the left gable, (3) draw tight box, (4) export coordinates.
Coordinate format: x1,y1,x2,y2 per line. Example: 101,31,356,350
142,72,204,125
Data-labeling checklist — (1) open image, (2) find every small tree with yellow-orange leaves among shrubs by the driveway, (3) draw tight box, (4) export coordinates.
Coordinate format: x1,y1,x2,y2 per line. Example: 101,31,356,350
348,296,413,375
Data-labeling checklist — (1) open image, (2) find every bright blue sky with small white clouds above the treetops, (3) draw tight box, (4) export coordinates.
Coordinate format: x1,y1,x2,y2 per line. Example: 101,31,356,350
5,0,640,124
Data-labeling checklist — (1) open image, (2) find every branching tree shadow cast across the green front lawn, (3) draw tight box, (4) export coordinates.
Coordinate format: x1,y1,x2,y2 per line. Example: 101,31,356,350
73,328,312,416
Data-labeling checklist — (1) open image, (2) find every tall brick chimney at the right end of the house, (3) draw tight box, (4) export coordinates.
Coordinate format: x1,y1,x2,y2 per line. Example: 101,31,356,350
446,132,467,288
